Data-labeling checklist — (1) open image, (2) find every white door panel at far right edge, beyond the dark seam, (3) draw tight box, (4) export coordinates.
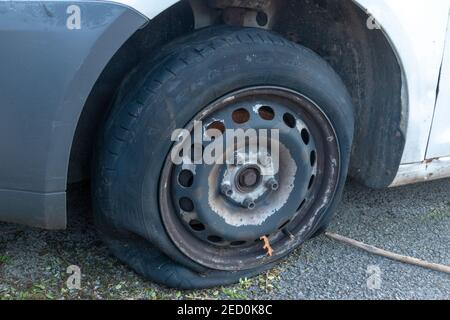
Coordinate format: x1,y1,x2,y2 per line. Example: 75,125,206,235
427,15,450,159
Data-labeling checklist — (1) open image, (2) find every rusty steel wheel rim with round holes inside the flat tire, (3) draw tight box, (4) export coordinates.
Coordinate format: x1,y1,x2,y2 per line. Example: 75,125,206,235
159,87,340,271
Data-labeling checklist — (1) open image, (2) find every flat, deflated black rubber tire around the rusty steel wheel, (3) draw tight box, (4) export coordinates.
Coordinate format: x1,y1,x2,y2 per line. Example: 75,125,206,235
92,26,354,289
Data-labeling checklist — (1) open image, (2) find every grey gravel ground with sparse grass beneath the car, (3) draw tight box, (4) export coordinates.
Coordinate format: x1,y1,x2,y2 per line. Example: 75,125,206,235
0,180,450,299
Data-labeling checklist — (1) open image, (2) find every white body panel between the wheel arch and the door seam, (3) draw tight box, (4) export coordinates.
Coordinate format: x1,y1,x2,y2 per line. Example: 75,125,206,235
358,0,450,164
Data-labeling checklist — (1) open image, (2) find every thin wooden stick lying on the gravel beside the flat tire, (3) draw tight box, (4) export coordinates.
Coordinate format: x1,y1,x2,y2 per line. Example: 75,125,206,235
325,232,450,274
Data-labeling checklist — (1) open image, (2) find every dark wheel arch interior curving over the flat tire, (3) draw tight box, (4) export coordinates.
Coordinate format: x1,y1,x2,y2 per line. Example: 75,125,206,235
68,0,408,188
